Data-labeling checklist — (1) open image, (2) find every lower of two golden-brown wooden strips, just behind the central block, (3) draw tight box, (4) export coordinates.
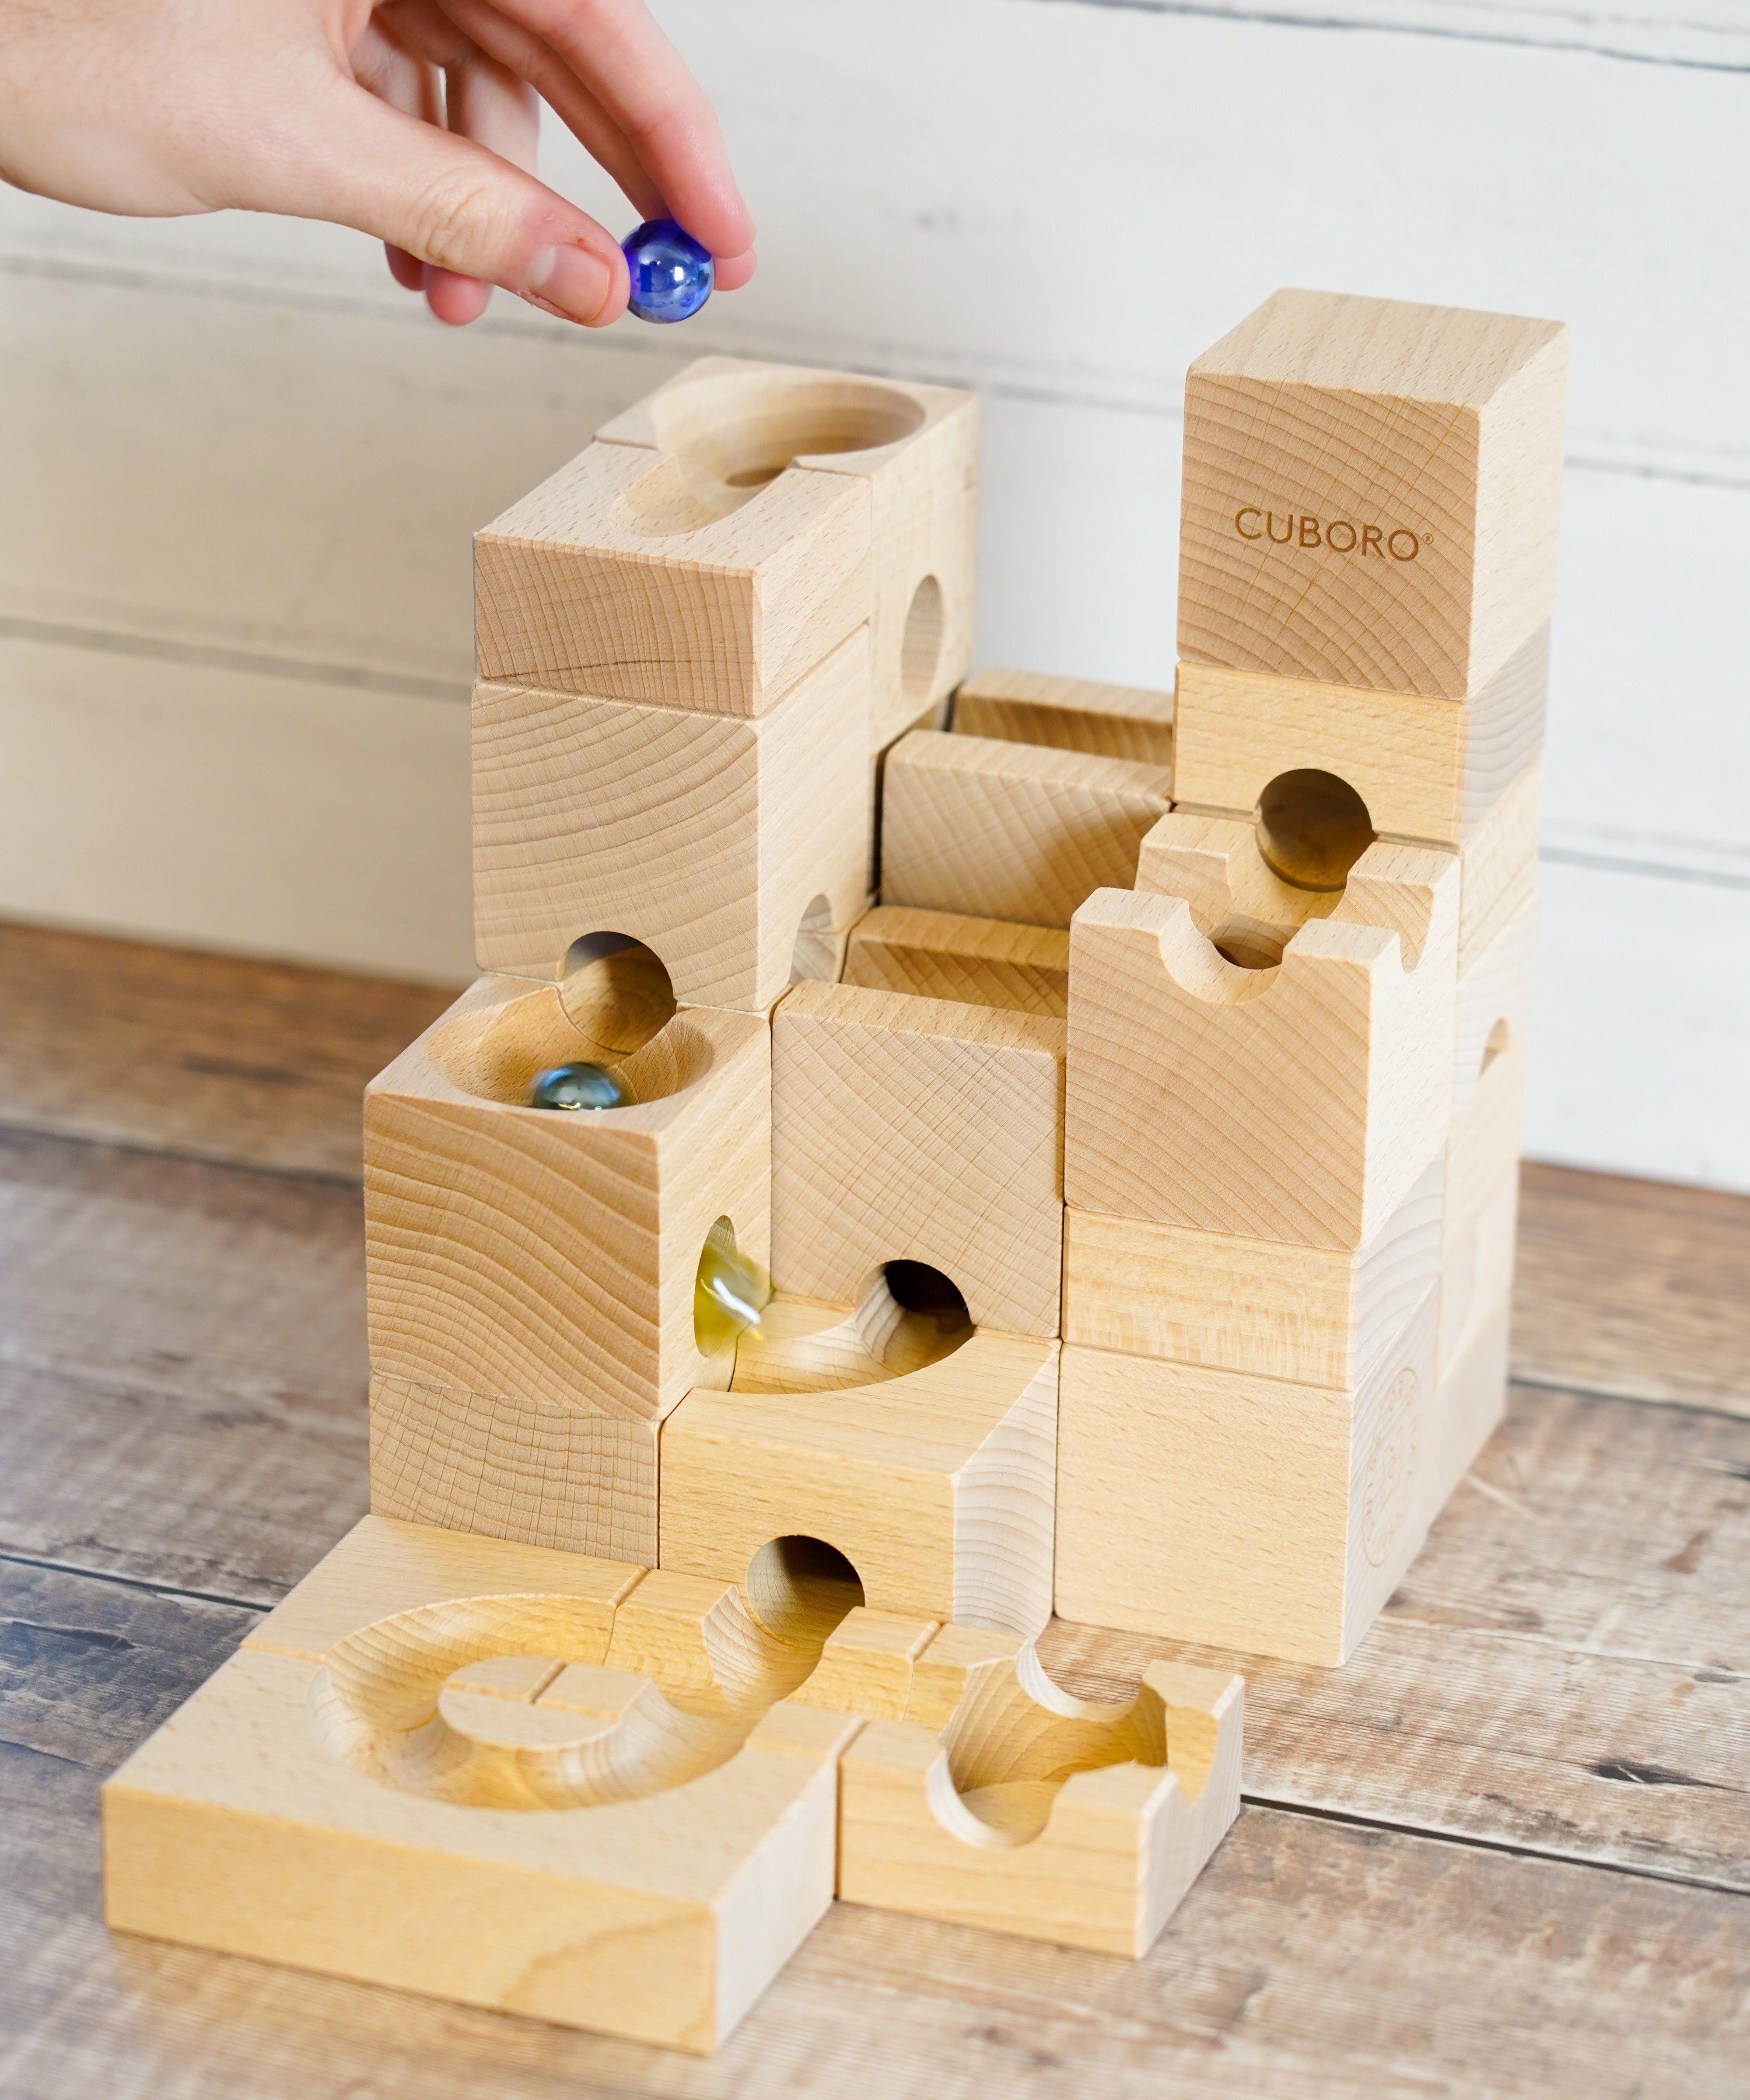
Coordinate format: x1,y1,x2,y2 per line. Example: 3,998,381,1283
843,907,1067,1021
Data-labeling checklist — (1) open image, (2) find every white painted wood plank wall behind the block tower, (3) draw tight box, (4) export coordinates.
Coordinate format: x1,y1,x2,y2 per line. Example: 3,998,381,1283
0,0,1750,1189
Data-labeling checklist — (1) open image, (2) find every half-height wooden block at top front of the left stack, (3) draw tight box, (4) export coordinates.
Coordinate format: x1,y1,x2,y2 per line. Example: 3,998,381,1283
475,445,872,714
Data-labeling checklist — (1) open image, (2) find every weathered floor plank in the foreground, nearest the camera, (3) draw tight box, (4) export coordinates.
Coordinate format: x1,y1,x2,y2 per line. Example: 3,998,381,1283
0,1571,1750,2100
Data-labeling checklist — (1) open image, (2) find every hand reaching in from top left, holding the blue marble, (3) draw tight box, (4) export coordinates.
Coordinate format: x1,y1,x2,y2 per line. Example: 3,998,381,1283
0,0,754,328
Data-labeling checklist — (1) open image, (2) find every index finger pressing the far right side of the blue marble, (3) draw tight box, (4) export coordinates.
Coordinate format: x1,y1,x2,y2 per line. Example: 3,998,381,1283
487,0,754,256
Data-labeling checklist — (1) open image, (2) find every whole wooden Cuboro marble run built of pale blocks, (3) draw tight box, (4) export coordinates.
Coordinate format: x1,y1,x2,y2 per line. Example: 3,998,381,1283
103,292,1567,2052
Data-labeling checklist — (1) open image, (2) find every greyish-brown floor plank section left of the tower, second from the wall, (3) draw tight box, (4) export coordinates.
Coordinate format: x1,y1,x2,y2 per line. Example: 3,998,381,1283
0,1132,368,1604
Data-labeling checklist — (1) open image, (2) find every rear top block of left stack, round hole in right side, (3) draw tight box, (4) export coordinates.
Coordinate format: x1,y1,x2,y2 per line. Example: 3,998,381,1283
588,357,979,750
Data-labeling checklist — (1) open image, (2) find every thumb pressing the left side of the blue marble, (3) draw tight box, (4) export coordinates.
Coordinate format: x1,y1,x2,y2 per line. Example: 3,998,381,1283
265,82,630,328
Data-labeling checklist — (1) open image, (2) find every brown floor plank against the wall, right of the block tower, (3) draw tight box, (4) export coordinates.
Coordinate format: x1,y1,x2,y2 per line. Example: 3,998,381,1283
1512,1161,1750,1415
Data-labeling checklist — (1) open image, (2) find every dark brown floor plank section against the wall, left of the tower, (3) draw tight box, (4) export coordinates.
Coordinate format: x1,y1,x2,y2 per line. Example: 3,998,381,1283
0,922,456,1180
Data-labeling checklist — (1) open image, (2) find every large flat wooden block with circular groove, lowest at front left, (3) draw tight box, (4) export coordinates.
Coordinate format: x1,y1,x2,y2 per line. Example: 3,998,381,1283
103,1525,857,2052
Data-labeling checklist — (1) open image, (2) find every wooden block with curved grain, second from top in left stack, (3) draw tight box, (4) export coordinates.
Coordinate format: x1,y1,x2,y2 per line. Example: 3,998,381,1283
472,617,872,1012
